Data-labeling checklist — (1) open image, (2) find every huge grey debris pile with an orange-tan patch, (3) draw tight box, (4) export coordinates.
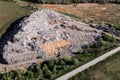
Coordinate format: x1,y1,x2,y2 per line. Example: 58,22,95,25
0,9,101,64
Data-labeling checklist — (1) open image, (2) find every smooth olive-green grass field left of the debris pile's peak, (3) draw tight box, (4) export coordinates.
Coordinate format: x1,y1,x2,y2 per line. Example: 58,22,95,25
0,1,31,35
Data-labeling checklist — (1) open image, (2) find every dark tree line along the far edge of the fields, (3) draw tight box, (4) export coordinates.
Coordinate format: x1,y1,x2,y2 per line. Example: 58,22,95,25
25,0,120,4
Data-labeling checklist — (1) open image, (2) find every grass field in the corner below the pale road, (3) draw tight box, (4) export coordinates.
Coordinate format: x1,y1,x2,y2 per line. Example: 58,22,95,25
70,52,120,80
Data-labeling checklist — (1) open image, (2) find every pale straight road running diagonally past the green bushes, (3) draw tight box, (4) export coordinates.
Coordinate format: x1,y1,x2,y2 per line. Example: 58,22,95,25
56,46,120,80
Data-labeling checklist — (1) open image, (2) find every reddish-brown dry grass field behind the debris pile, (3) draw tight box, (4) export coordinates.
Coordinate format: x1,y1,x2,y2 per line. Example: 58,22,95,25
38,4,120,24
